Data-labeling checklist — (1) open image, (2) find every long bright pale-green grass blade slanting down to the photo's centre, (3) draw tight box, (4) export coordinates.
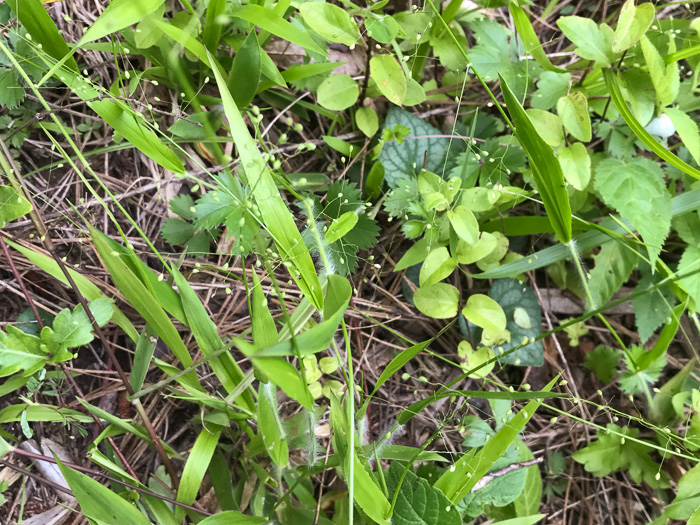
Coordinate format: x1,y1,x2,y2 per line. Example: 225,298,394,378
206,49,323,310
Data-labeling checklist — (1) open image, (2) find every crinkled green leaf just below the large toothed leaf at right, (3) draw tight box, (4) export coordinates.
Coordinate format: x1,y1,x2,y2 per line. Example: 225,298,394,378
586,238,639,310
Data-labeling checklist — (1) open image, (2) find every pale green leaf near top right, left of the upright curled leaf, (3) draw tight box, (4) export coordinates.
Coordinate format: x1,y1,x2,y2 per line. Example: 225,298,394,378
557,16,615,66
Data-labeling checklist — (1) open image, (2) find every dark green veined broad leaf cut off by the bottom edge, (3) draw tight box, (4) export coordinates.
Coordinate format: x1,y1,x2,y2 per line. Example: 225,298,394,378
387,461,462,525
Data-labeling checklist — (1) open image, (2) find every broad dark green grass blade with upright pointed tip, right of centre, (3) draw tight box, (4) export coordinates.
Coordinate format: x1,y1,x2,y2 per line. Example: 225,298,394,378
498,75,571,244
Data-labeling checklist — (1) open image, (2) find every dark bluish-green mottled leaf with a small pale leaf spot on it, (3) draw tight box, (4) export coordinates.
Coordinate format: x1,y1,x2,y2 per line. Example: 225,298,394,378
489,279,544,366
